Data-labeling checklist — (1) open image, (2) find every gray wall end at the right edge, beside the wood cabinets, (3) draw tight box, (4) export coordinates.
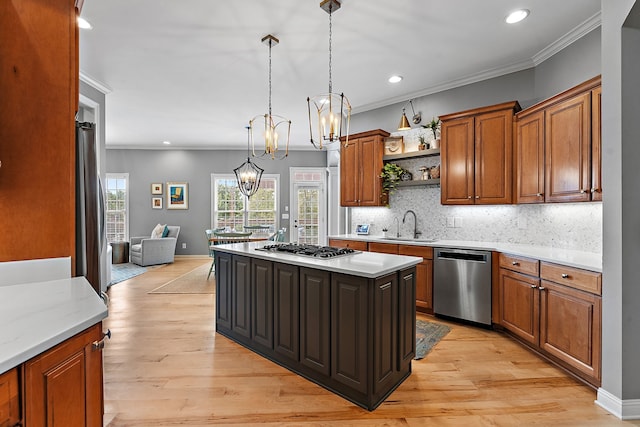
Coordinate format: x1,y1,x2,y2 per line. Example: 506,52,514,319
598,0,640,408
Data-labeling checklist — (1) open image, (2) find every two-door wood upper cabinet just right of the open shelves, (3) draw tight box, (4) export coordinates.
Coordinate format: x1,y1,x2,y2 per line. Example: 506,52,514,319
440,101,520,205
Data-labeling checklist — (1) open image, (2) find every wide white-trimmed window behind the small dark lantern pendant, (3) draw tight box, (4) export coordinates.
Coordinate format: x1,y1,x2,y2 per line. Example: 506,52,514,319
211,174,280,231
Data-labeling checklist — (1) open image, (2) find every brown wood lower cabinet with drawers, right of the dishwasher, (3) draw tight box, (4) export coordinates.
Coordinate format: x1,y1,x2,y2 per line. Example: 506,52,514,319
499,254,602,386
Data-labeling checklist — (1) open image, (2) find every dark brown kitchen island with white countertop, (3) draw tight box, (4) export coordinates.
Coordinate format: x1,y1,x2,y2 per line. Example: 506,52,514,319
214,242,422,410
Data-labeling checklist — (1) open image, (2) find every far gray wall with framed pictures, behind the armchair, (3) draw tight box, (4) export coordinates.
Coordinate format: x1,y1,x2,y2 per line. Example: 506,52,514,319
107,149,327,255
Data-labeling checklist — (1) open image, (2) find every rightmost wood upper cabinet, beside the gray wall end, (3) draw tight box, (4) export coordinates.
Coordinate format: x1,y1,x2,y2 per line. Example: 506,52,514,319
516,76,602,203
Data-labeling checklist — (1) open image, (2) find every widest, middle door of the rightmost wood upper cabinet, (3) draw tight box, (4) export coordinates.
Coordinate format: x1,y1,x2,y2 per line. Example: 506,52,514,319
545,92,591,202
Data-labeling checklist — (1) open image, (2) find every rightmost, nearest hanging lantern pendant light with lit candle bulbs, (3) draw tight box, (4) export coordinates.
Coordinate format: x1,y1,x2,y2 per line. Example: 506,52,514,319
307,0,351,150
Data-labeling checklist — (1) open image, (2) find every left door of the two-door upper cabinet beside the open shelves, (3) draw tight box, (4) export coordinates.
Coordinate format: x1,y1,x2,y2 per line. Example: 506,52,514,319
440,117,474,205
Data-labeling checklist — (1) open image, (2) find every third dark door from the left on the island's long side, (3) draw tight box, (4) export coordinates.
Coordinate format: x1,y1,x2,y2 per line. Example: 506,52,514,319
251,258,273,350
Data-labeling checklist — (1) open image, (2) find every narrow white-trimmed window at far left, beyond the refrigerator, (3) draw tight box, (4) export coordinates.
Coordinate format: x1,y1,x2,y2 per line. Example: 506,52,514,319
105,173,129,243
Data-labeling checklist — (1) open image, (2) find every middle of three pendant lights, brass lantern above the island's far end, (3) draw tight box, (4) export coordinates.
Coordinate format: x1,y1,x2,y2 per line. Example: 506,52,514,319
249,34,291,159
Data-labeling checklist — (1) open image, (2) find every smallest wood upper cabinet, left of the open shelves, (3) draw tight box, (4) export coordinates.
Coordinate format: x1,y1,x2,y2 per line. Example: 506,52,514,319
340,129,389,206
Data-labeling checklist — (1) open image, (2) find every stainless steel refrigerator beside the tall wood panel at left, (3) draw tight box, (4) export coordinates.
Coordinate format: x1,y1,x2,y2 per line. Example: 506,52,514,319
75,121,108,295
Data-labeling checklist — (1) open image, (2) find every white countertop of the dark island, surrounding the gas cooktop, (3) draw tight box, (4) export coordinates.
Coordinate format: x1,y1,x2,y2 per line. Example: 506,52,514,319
214,242,422,279
